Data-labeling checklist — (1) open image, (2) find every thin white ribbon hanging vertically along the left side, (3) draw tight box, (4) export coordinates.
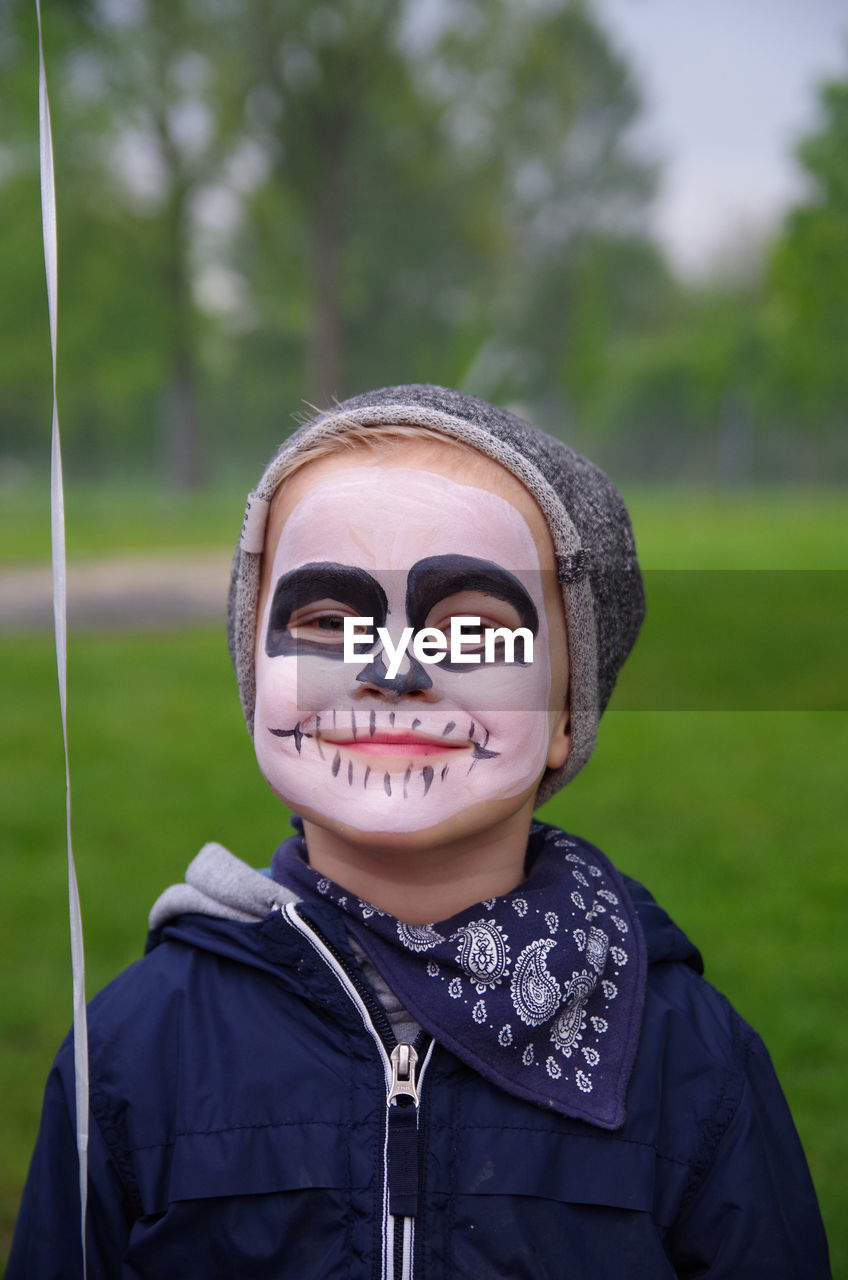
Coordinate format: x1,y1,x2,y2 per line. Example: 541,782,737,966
36,0,88,1280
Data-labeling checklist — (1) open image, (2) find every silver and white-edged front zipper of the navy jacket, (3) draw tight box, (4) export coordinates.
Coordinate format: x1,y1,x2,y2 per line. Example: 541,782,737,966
282,902,436,1280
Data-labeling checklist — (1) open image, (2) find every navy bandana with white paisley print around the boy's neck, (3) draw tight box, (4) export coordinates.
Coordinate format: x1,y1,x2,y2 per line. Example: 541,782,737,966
272,819,646,1129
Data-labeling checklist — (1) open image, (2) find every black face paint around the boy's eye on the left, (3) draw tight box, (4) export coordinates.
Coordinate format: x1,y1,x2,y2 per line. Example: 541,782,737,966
265,562,388,660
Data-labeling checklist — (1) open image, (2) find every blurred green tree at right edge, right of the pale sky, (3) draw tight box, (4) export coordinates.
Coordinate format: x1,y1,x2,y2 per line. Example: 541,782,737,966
584,58,848,484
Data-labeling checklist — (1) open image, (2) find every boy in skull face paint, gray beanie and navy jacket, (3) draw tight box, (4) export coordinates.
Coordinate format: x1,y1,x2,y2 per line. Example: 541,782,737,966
9,387,829,1280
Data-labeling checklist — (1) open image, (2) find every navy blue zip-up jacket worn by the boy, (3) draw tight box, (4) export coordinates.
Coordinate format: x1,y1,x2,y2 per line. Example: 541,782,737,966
8,883,830,1280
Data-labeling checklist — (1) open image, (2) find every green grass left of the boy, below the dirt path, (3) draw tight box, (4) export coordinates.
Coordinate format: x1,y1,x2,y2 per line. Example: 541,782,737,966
0,630,287,1253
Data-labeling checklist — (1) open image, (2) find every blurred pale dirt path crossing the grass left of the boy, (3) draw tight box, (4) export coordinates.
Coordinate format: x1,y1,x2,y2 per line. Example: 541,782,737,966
0,552,231,632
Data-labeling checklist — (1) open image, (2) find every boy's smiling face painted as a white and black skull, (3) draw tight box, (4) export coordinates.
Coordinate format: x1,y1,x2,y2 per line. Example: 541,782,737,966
254,442,569,847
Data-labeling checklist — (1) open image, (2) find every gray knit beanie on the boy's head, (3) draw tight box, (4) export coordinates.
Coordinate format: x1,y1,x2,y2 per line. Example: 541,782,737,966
227,385,644,804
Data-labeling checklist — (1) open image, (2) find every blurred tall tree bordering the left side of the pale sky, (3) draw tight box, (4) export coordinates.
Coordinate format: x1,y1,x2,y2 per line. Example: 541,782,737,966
430,0,666,408
